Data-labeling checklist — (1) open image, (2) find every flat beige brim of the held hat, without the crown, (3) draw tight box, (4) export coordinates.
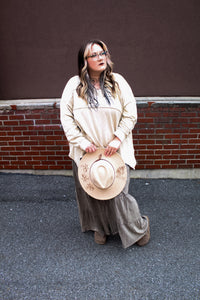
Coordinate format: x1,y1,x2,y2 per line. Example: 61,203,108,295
78,149,127,200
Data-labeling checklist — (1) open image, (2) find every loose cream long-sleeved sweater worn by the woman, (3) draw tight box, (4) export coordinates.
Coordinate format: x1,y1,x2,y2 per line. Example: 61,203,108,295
60,73,137,168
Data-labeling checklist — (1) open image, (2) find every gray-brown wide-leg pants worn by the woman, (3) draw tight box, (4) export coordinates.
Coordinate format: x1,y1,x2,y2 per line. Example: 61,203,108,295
73,162,148,248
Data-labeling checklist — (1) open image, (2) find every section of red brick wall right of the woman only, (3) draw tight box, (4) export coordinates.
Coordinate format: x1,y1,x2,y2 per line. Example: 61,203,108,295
133,102,200,169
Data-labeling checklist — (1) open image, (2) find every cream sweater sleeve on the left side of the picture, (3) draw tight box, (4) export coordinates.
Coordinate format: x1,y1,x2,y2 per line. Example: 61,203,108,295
60,76,91,150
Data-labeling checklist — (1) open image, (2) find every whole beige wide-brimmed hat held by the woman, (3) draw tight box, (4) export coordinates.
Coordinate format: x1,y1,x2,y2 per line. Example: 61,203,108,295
78,149,127,200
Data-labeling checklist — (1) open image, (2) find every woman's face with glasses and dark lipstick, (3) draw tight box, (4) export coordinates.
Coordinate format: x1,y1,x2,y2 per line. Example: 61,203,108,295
87,44,107,77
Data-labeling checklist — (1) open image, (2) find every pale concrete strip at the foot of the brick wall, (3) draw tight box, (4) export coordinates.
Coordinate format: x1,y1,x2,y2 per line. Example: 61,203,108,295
0,169,200,179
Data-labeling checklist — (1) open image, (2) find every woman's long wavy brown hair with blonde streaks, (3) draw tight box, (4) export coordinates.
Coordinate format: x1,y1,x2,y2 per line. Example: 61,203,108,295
77,40,119,108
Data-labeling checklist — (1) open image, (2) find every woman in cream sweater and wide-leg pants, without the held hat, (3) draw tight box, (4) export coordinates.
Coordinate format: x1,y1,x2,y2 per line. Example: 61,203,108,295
60,40,150,248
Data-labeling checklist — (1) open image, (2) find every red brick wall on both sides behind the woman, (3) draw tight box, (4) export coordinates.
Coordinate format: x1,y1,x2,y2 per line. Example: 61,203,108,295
0,102,200,170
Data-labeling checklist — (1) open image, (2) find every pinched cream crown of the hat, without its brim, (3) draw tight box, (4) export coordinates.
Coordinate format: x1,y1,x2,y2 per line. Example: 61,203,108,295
90,159,115,189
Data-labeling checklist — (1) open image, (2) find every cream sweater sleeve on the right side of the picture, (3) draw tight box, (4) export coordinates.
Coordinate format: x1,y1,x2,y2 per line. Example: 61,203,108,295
115,74,137,142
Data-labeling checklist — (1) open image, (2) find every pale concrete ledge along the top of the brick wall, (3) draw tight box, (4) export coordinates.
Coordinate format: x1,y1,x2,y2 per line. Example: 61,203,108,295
0,96,200,110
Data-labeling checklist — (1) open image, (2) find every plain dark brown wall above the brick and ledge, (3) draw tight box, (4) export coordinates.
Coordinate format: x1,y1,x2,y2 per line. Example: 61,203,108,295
0,0,200,99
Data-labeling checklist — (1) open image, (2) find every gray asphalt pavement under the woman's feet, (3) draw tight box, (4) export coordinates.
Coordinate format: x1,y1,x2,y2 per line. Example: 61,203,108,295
0,173,200,300
